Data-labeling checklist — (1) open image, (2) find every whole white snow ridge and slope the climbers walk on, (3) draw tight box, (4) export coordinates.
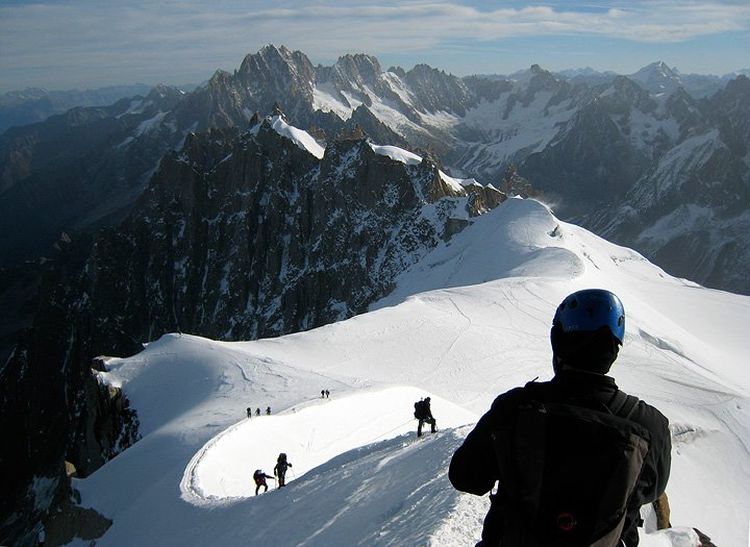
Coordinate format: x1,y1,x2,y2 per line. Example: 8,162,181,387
75,199,750,547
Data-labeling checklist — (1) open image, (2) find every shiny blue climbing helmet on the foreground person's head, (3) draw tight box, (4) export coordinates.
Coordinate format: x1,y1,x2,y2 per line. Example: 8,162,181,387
552,289,625,344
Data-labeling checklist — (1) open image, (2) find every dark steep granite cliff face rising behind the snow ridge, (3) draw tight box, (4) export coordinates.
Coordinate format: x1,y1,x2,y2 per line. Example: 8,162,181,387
75,117,488,347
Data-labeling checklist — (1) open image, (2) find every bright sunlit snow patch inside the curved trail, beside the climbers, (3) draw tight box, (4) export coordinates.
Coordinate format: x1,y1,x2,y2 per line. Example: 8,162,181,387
182,387,476,500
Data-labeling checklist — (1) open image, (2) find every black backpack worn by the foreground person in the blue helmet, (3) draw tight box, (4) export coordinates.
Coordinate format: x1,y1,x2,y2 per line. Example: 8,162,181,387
492,391,650,547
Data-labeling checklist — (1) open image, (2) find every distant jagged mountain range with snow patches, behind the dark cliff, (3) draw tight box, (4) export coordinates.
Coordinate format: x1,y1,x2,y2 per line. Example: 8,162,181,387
0,46,750,294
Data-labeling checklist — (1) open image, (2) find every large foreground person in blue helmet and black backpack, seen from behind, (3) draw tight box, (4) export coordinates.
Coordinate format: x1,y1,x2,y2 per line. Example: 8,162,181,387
448,289,671,547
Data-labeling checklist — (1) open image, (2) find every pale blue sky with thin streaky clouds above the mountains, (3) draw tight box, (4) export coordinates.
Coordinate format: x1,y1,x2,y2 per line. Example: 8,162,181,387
0,0,750,91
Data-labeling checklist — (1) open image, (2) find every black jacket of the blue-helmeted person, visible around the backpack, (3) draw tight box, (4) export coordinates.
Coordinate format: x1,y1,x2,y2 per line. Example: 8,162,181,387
448,370,671,547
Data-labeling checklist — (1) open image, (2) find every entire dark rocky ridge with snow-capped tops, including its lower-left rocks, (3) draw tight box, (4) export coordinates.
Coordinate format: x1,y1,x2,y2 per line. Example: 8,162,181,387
0,115,504,544
